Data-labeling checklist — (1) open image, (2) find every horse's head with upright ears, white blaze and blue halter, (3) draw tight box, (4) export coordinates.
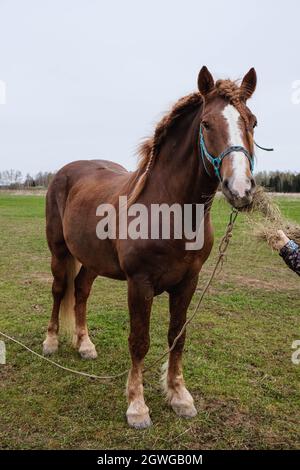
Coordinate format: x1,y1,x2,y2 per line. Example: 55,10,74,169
198,67,256,208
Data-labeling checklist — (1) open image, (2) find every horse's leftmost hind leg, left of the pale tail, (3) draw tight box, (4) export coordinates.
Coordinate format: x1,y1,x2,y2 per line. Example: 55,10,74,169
43,254,68,355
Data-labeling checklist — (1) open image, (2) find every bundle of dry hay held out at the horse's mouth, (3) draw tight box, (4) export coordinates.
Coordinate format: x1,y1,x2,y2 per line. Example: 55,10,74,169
247,186,300,249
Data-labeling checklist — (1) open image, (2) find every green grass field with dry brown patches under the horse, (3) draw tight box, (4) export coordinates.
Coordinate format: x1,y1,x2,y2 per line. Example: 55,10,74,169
0,194,300,449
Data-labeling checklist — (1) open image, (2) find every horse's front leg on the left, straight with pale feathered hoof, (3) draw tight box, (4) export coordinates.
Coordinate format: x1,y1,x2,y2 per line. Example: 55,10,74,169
126,279,153,429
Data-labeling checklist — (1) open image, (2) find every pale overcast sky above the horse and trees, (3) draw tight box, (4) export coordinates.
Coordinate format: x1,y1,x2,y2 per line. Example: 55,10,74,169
0,0,300,174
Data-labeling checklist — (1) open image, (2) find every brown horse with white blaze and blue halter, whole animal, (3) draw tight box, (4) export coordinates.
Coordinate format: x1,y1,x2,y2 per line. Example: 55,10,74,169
43,67,256,428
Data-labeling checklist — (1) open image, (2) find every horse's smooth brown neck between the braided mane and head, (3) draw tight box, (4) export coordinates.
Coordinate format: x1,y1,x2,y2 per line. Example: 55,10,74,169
146,112,218,204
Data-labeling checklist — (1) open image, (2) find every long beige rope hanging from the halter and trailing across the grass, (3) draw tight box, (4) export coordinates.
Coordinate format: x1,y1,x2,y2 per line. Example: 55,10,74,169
0,208,238,381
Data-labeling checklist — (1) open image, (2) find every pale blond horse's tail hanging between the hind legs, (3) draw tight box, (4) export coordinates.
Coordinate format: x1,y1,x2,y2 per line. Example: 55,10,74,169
59,255,81,339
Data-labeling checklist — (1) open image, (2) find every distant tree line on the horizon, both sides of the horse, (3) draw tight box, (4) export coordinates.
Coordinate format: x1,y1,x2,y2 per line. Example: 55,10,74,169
0,170,300,193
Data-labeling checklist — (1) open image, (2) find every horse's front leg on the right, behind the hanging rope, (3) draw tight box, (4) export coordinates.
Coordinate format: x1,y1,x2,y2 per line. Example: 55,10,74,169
162,275,198,418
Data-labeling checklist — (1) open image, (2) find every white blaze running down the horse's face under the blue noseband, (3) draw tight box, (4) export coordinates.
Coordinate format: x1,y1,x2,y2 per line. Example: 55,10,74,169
222,104,250,197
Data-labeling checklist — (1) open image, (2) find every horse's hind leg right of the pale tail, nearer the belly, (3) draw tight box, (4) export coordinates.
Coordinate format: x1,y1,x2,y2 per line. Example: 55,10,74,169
74,266,97,359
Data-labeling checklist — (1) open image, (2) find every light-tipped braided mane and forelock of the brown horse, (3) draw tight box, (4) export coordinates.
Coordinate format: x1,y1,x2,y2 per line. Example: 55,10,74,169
128,80,247,205
